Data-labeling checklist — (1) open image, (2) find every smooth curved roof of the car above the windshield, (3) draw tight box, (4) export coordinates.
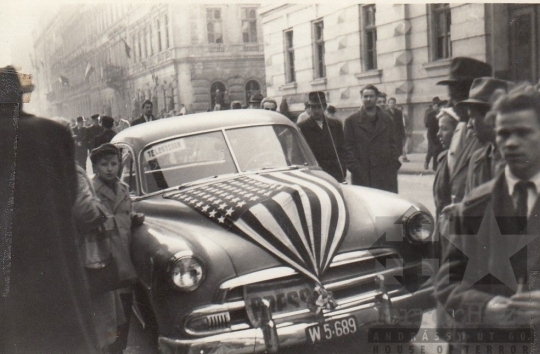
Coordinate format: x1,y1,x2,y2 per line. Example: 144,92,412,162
112,109,296,150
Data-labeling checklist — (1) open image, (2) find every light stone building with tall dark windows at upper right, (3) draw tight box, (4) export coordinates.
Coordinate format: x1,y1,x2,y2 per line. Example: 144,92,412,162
259,2,540,149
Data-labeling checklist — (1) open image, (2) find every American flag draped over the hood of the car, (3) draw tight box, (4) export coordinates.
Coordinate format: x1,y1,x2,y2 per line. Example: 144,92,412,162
167,170,348,283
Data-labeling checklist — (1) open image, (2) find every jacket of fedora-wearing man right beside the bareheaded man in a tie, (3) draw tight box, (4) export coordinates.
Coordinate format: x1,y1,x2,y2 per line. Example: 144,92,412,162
465,144,505,195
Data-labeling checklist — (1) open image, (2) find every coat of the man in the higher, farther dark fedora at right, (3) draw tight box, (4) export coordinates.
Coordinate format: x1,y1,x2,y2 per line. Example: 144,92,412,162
450,135,483,203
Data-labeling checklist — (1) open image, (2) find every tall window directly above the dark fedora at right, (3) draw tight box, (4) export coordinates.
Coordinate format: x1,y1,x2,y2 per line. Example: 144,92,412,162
430,4,452,60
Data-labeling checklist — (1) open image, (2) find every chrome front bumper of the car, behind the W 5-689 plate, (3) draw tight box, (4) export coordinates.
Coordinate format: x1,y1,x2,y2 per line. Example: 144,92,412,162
159,286,435,354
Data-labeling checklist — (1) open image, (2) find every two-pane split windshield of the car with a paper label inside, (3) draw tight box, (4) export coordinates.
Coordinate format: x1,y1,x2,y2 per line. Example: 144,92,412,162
141,125,316,193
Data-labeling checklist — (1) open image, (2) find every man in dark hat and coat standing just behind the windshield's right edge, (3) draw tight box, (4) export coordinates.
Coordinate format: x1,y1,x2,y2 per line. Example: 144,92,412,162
298,91,346,182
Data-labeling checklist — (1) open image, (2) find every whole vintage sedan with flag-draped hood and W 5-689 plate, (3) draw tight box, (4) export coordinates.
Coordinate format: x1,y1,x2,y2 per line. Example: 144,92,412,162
113,110,434,354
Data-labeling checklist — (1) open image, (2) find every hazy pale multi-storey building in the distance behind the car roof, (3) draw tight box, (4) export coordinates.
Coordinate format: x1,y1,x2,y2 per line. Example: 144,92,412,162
34,3,265,118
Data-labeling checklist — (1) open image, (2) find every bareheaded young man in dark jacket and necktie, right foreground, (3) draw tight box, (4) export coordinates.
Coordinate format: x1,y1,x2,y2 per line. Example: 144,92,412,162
435,85,540,353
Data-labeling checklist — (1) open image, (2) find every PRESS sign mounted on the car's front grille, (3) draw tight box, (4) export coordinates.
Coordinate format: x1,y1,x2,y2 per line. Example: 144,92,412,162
244,280,313,324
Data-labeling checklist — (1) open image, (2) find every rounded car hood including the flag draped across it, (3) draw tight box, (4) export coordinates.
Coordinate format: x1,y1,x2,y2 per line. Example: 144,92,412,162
141,170,430,276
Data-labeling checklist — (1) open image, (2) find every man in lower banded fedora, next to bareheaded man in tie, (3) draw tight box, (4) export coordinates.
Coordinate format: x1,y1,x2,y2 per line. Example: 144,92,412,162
454,77,513,194
